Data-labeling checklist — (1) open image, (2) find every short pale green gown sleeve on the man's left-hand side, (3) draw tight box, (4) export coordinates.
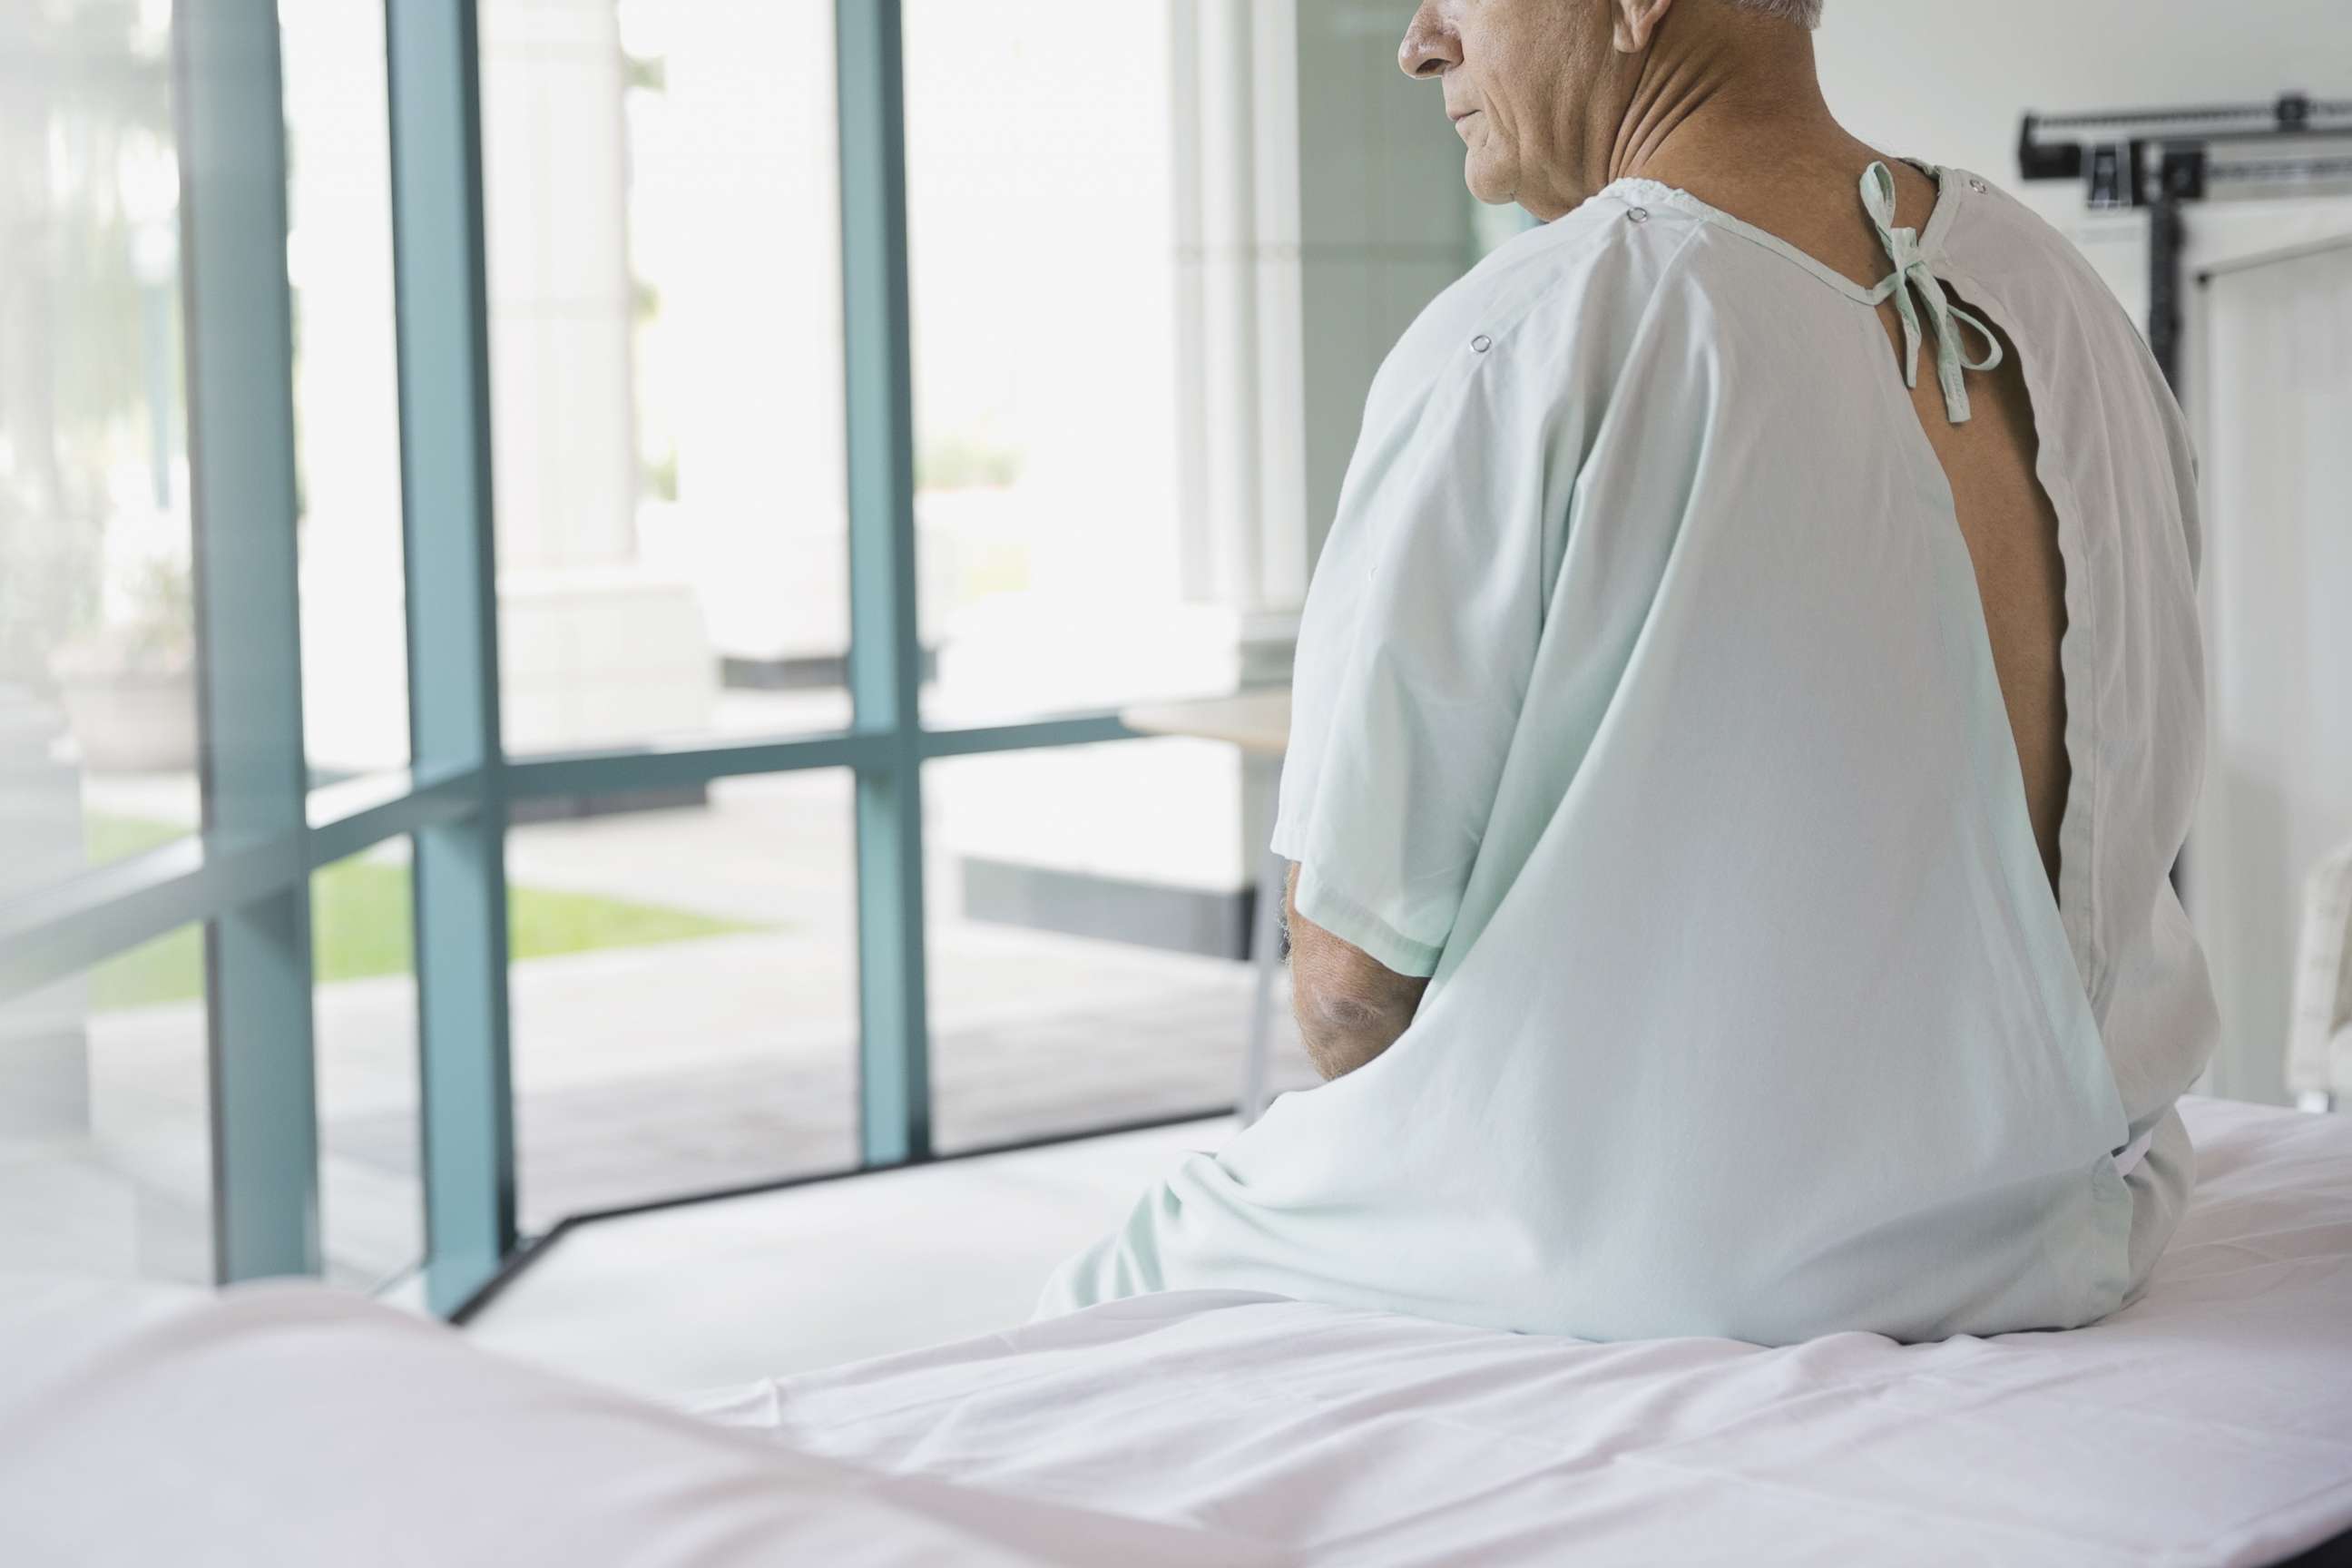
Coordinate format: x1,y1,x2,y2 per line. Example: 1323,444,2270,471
1272,338,1550,975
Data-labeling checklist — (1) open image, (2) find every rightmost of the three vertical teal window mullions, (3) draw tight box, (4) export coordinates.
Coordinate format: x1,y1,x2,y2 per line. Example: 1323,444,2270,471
835,0,931,1166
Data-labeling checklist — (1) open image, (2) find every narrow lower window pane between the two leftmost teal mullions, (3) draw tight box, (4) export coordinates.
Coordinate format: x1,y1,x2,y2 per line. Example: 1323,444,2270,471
310,839,426,1290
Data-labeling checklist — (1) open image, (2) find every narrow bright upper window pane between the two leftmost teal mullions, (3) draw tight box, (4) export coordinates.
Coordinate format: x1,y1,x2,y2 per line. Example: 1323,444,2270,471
279,0,409,783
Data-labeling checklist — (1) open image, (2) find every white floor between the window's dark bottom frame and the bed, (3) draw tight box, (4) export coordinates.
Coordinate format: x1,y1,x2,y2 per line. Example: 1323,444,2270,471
468,1122,1232,1394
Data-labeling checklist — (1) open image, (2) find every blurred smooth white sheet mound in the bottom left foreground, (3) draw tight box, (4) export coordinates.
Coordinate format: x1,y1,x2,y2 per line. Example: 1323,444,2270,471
0,1277,1289,1568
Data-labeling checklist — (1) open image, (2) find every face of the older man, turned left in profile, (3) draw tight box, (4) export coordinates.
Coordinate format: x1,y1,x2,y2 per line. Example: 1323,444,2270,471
1397,0,1616,219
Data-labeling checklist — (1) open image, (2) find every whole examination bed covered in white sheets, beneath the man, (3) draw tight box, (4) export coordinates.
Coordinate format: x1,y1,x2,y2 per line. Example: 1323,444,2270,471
0,1100,2352,1568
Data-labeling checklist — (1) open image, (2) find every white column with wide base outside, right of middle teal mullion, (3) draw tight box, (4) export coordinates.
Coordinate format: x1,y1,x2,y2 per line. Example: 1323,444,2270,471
467,0,718,752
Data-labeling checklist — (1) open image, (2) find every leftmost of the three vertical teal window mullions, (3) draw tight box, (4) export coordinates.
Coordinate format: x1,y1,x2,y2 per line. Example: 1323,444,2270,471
172,5,320,1281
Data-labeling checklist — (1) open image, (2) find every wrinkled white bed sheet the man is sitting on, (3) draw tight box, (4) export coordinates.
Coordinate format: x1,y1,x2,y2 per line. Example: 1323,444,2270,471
701,1100,2352,1568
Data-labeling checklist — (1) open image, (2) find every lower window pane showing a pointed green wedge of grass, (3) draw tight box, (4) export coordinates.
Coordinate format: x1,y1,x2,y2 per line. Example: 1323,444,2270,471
505,771,858,1232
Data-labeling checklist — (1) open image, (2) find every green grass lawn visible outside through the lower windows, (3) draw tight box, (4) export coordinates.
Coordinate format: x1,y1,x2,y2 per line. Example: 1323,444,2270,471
87,816,767,1014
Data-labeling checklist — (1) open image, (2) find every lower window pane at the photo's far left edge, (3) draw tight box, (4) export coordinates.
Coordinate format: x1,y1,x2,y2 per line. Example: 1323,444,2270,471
0,926,211,1284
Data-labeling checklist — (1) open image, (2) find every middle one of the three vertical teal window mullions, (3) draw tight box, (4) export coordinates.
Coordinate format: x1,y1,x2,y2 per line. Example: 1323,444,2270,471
383,0,515,1314
